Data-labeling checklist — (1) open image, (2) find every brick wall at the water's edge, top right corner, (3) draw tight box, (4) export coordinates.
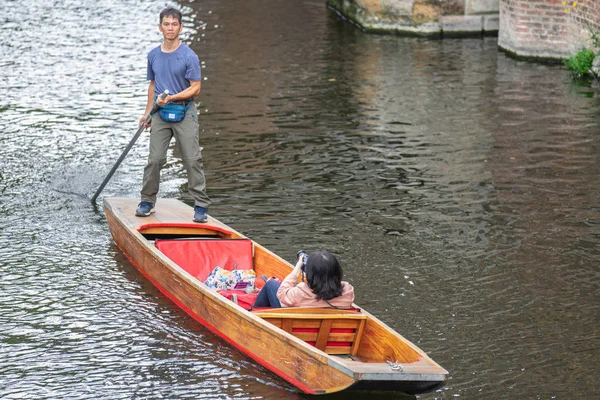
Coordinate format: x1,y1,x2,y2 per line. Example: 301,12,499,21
498,0,600,58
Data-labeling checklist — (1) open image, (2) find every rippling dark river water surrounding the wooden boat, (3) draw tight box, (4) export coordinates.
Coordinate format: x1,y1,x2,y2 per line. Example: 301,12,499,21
0,0,600,399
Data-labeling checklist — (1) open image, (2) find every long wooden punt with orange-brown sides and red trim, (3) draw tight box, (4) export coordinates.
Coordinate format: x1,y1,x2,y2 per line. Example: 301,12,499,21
104,198,448,394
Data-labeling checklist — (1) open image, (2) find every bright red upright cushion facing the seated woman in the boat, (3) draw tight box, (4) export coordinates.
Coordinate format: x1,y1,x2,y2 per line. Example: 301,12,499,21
155,239,253,282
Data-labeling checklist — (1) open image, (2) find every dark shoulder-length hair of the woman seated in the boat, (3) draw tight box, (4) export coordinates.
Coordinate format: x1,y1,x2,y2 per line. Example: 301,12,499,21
305,250,342,300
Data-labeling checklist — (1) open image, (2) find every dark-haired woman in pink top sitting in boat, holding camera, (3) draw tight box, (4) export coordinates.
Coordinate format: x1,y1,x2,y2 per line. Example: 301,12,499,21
252,250,354,308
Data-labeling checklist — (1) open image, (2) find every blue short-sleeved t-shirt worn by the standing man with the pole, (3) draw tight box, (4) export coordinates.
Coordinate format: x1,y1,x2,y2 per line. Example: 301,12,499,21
146,43,202,95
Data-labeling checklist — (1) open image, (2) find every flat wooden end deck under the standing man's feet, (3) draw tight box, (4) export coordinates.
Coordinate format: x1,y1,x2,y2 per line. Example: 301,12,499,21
107,197,241,236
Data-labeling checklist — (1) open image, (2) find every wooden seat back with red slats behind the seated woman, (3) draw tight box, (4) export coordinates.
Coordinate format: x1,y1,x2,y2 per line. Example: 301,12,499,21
253,307,367,356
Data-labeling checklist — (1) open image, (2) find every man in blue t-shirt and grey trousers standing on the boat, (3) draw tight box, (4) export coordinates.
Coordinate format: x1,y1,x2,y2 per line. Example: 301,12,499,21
135,7,210,222
